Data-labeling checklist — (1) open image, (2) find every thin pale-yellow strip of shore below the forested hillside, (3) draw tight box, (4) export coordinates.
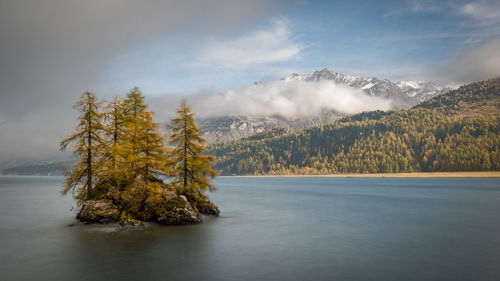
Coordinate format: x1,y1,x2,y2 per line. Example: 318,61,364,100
220,171,500,178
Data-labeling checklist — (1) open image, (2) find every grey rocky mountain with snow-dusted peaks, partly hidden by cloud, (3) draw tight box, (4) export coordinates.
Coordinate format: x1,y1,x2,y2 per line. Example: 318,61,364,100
200,68,451,143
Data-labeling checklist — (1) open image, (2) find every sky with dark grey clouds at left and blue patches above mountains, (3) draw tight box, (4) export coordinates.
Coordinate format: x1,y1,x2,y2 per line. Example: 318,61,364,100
0,0,500,165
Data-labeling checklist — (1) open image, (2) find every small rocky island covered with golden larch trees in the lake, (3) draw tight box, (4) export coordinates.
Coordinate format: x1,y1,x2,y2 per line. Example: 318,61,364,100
61,88,220,227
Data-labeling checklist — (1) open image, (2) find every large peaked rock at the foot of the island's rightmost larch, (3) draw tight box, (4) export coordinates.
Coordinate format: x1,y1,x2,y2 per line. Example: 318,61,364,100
157,195,201,225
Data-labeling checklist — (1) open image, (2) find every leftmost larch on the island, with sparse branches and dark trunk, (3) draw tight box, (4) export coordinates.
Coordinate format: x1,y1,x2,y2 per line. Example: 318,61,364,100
60,91,103,203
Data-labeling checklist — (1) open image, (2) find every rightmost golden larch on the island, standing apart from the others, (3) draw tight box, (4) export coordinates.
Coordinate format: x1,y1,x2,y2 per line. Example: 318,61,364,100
169,100,217,205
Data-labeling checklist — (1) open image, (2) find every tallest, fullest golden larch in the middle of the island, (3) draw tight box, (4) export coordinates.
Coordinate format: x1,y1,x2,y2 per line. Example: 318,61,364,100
110,88,168,216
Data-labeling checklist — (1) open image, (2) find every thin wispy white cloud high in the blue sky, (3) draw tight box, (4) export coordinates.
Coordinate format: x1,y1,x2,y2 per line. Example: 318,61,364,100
191,19,306,69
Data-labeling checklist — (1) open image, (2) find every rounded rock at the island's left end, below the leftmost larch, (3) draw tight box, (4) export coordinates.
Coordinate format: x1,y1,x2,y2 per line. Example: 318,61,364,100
76,200,120,223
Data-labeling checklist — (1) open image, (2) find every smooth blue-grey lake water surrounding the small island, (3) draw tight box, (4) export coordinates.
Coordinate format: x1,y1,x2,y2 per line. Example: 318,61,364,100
0,177,500,281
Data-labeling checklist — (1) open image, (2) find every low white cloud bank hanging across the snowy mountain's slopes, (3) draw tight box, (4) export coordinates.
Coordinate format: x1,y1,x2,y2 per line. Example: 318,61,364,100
182,80,391,118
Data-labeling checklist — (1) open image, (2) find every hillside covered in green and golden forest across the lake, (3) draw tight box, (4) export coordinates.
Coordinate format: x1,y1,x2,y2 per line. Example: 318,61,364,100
208,75,500,175
